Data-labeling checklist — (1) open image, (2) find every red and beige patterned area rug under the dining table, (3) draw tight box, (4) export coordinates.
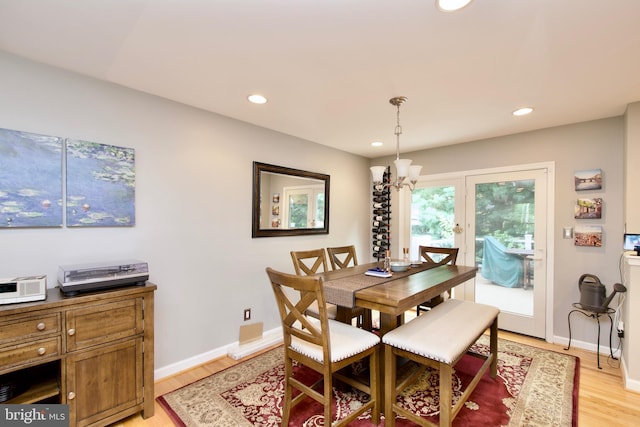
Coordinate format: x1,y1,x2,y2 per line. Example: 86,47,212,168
157,337,580,427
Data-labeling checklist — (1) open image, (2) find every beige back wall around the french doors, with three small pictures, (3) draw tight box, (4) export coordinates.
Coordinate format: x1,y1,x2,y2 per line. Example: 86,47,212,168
370,117,624,345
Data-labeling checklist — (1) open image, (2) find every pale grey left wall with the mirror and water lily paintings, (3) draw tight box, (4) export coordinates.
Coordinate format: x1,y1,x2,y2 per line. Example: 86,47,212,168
0,54,371,369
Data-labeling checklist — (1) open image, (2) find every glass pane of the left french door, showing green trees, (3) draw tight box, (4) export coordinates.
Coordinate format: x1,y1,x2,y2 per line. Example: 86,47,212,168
409,186,455,260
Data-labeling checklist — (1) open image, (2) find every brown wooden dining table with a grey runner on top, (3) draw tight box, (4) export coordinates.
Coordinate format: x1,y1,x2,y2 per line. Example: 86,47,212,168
319,263,478,336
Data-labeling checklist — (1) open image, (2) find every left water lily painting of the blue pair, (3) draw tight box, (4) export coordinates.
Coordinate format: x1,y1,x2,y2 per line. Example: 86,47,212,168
0,129,62,228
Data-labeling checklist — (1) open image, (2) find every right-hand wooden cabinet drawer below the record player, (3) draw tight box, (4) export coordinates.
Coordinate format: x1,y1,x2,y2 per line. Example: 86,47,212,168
66,298,144,351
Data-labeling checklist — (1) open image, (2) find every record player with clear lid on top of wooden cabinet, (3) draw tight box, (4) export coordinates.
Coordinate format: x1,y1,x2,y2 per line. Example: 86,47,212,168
58,259,149,295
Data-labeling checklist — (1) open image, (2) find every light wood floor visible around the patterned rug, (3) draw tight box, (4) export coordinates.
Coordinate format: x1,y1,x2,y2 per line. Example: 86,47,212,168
115,331,640,427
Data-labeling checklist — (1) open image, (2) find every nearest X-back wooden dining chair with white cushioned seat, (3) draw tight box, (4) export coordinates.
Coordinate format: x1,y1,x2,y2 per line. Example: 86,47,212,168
266,268,381,426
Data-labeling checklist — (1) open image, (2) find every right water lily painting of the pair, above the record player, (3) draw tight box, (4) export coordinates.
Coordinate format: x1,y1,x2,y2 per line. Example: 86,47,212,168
66,139,135,227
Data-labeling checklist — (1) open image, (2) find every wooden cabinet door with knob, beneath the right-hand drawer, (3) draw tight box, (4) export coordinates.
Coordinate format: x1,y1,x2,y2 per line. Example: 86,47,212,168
65,338,143,427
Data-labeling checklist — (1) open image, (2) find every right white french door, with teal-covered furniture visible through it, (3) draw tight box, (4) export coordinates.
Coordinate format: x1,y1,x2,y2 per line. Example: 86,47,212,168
465,169,549,338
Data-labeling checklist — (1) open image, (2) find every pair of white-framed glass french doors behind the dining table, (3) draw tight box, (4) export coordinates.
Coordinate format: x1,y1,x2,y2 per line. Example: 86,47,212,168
408,167,552,338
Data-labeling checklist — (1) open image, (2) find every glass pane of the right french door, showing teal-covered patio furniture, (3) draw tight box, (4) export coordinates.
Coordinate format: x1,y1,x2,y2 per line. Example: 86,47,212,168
475,179,535,316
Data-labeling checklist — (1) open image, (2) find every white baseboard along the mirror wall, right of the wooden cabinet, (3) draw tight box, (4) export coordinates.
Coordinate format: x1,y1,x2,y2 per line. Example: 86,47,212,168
154,327,282,381
